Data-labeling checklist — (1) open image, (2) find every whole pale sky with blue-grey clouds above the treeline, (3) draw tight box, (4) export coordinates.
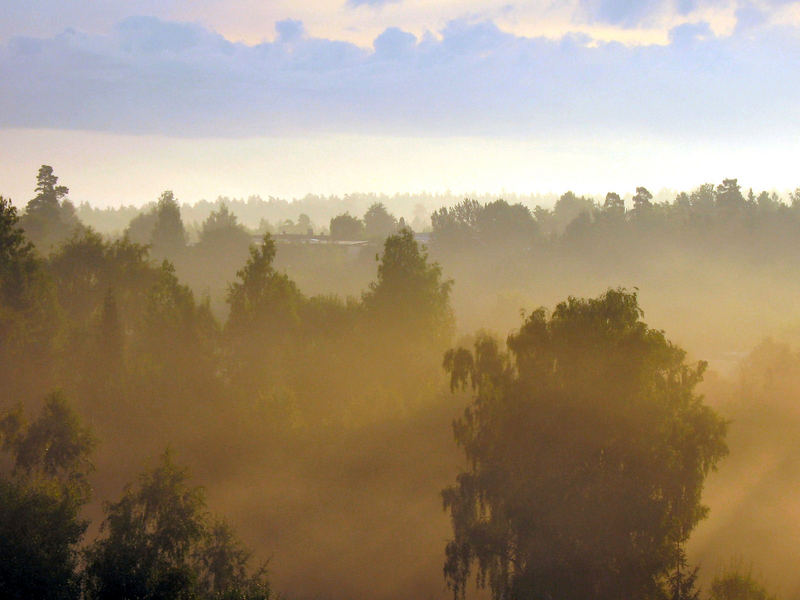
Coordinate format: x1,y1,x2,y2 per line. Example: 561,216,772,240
0,0,800,205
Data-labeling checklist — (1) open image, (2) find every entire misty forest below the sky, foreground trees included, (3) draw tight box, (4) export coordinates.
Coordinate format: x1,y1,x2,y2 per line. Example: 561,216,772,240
0,165,800,600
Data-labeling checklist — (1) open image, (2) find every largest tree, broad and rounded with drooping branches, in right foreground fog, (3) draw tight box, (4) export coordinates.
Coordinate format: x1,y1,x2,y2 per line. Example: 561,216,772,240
443,290,726,600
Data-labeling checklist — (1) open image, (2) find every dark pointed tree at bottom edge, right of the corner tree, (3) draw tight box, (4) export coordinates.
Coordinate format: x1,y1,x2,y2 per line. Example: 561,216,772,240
85,452,270,600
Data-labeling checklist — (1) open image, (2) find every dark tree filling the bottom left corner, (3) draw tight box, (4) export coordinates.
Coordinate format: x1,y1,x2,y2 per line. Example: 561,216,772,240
0,394,95,600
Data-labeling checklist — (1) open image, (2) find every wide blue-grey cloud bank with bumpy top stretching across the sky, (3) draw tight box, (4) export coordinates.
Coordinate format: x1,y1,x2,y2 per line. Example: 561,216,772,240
0,17,800,139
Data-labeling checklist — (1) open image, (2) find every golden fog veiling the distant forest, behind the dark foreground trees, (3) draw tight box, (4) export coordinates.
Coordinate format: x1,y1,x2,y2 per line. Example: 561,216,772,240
0,167,800,599
